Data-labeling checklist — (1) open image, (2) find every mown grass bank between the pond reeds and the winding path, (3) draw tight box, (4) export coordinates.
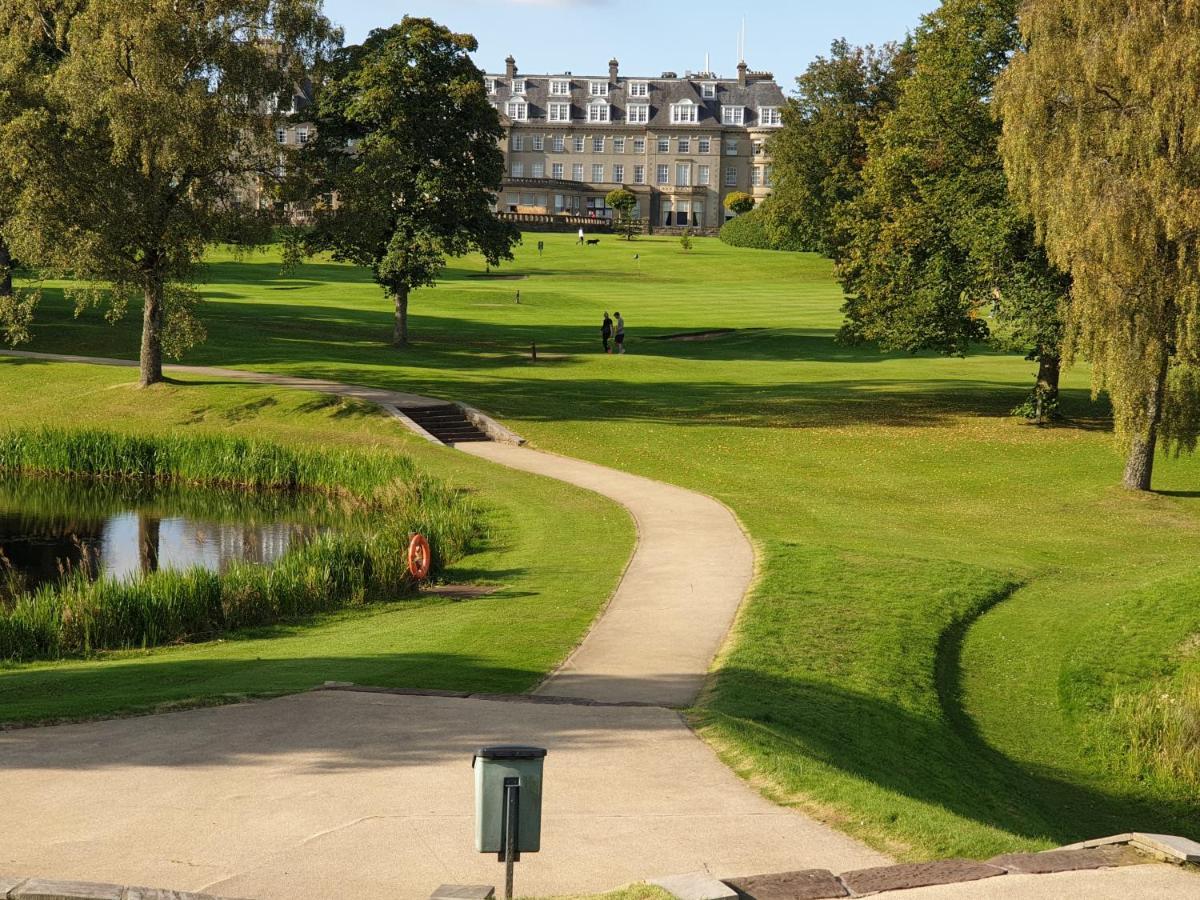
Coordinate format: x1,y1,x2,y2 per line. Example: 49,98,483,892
0,362,634,722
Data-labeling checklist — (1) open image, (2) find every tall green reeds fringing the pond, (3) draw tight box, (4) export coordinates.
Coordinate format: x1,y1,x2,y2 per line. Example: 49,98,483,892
0,428,481,661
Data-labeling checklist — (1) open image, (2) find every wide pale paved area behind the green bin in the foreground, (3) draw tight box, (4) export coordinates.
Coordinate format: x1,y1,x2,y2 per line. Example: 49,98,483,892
0,691,888,900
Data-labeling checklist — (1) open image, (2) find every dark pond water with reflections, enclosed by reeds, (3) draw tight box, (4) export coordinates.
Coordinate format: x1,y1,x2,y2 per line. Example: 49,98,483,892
0,479,344,595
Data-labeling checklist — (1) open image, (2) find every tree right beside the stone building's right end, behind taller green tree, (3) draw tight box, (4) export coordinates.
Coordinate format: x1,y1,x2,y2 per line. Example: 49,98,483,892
763,40,912,257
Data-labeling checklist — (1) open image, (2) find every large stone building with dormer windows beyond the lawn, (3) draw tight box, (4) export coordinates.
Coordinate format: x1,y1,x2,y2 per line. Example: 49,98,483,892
486,56,785,230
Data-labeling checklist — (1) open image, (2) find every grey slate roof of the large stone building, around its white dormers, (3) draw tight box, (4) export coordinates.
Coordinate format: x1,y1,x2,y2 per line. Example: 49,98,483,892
487,72,786,128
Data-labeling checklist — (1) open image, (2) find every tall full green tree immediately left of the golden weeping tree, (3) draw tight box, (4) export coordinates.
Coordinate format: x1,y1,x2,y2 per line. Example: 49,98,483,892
838,0,1069,420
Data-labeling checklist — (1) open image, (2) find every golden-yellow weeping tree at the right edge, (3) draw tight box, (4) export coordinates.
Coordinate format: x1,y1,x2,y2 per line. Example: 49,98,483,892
997,0,1200,491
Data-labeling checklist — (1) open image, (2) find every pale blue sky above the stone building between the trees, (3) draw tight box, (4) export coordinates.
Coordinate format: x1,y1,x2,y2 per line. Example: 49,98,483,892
325,0,938,86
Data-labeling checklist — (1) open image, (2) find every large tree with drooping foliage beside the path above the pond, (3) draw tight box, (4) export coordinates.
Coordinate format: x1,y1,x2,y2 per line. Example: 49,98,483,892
0,0,331,386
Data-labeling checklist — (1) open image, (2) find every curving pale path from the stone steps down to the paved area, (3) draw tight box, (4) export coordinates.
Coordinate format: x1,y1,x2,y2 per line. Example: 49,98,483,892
460,444,754,707
